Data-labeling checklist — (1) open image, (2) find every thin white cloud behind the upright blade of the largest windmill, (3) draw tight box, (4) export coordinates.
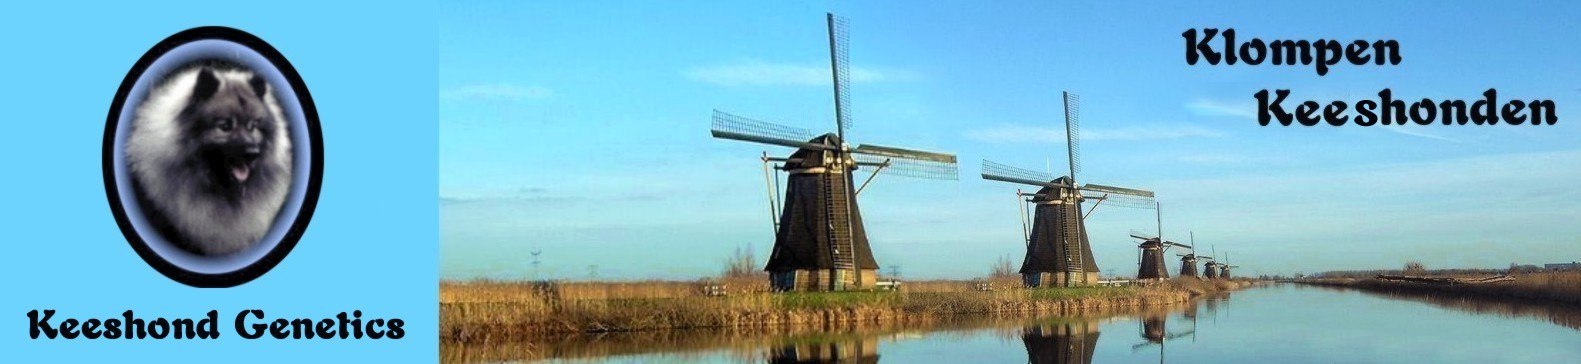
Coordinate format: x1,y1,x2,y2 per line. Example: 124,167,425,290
683,60,912,87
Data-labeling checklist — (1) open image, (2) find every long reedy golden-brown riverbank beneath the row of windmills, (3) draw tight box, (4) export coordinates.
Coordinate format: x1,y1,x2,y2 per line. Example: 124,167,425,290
440,279,1251,343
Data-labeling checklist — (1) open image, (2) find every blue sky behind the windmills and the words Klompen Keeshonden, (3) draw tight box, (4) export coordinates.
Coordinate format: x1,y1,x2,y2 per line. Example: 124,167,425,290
438,2,1581,279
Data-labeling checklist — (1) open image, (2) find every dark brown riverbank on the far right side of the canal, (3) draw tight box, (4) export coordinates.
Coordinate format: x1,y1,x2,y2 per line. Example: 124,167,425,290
1296,271,1581,305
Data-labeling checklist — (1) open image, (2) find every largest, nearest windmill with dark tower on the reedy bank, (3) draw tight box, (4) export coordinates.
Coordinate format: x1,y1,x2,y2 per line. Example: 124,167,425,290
711,14,957,291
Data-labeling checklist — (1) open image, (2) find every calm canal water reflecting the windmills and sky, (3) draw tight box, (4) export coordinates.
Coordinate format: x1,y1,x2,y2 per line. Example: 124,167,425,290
441,285,1581,364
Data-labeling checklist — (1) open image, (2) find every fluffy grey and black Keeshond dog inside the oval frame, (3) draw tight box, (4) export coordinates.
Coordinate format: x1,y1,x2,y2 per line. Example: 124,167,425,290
125,62,291,256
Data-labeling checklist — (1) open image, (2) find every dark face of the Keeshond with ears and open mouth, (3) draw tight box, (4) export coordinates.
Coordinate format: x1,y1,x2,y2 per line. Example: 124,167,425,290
182,68,278,201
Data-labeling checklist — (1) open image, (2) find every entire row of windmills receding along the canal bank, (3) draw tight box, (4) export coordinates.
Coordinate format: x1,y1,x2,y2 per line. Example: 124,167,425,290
711,14,1235,291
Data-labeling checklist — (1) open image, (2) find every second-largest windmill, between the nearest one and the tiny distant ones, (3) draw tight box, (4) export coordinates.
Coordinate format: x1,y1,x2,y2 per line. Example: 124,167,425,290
982,92,1156,286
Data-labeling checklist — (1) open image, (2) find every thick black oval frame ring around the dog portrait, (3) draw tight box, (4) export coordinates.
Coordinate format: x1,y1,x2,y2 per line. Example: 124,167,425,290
103,27,324,288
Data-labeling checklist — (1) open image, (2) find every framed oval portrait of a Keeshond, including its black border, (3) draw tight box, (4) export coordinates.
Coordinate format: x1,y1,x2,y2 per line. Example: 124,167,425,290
103,27,323,288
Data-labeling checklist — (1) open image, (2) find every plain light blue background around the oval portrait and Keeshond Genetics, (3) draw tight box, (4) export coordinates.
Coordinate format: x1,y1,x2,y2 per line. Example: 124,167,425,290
0,2,438,362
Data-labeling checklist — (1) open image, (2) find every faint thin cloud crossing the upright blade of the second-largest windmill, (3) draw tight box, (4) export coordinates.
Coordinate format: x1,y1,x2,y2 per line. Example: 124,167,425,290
966,125,1224,142
